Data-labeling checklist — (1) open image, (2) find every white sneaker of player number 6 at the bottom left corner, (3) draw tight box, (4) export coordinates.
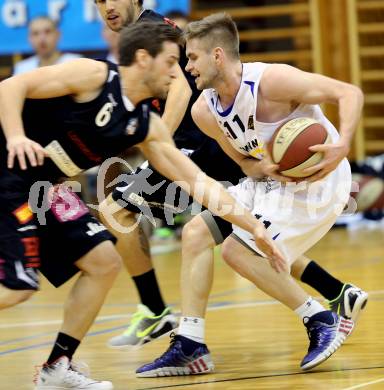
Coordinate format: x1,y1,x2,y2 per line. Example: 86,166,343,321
35,356,113,390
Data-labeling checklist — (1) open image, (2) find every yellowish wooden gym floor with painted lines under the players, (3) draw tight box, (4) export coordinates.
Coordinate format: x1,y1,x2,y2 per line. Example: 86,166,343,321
0,229,384,390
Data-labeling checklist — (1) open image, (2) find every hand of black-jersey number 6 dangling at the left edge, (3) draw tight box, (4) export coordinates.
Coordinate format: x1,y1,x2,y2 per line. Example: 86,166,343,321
7,135,48,170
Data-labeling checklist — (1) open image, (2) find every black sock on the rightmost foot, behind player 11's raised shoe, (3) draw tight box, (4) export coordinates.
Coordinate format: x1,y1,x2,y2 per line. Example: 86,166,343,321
301,261,344,301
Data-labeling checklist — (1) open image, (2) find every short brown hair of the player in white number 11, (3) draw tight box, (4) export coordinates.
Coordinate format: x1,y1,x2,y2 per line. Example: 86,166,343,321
184,12,240,59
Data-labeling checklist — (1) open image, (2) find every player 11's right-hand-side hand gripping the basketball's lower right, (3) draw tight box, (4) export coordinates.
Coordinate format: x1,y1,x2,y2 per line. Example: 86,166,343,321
303,141,349,182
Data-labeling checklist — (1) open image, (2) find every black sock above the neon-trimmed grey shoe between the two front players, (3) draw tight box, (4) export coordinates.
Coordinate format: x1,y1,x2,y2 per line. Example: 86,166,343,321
132,269,165,316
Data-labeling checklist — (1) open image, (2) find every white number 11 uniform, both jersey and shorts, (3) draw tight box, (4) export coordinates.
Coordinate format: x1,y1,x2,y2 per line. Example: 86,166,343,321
203,62,351,263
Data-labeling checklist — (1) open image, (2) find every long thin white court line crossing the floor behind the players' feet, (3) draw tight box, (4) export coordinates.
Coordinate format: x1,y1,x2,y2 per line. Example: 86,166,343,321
0,290,384,329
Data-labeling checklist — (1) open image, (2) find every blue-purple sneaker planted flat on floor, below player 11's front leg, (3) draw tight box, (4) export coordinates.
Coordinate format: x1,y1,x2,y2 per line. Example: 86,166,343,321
136,334,214,378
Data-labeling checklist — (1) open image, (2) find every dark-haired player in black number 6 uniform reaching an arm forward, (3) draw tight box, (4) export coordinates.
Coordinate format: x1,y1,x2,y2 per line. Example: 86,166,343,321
0,23,284,390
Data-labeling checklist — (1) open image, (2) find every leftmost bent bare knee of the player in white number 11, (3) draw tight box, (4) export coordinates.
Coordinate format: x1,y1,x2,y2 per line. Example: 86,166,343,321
182,216,216,251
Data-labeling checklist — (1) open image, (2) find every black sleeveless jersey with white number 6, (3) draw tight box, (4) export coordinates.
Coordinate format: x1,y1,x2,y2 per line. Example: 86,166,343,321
0,61,150,181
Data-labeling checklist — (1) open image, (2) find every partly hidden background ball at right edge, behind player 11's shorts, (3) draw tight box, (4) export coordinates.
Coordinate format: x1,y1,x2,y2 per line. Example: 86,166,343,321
351,174,384,211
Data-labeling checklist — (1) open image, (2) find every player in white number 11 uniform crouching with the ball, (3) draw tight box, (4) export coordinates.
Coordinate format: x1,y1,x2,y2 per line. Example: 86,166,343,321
137,14,363,377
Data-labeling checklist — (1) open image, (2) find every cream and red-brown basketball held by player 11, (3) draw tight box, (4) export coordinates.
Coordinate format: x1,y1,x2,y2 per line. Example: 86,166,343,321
268,118,330,178
